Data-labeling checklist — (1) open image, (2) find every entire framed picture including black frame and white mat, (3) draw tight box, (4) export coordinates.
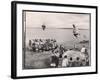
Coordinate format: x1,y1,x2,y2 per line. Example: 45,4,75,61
11,1,97,79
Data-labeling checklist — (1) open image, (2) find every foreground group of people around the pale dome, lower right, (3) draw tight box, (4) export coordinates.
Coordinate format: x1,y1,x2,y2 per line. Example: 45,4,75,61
50,46,89,67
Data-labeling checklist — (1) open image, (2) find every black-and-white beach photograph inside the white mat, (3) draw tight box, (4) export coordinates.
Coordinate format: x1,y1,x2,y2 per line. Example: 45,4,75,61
23,10,91,69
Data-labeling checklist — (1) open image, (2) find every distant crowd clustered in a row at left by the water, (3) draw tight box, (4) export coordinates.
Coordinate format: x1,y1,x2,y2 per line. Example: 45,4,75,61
29,39,58,52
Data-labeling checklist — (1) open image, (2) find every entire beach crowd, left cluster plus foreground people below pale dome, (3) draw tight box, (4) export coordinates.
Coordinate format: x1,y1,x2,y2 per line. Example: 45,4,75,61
29,39,89,67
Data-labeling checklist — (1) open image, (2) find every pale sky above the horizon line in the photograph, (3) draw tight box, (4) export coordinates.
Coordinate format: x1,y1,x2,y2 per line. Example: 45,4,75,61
26,11,90,29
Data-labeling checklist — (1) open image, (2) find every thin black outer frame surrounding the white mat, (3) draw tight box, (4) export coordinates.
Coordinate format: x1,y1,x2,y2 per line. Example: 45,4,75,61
11,1,98,79
